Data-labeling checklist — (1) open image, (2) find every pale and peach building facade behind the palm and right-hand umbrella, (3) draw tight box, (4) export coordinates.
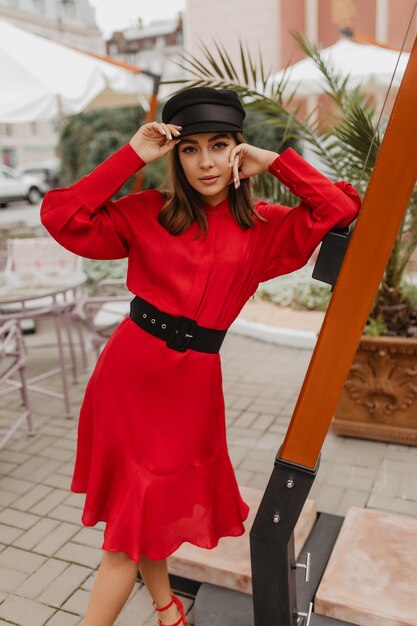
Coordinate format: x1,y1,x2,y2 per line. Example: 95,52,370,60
185,0,417,72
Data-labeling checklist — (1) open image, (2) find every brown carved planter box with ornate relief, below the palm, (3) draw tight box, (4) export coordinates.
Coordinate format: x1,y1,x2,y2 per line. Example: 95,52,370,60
333,336,417,445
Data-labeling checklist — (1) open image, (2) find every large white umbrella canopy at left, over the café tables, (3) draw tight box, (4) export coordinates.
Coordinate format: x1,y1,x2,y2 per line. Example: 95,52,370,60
0,20,153,123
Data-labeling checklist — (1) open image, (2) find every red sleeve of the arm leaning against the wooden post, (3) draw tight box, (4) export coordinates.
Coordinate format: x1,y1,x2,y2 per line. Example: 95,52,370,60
256,148,361,282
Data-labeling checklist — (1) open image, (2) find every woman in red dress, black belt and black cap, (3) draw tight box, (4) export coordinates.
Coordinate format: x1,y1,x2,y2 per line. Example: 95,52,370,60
41,88,360,626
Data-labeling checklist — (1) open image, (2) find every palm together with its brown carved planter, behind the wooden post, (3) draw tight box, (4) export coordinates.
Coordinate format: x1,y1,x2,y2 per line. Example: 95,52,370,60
167,35,417,445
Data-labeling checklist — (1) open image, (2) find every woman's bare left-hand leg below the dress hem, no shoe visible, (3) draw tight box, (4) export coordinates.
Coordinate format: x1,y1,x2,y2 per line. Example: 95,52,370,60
83,550,138,626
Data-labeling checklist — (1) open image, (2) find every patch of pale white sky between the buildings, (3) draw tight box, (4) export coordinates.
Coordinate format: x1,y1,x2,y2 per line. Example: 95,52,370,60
90,0,185,35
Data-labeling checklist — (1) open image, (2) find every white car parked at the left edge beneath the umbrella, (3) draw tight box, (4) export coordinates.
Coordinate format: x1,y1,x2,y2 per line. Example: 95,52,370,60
0,165,48,208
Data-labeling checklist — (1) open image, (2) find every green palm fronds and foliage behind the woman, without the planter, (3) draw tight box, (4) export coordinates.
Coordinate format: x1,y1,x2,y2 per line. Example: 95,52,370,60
167,34,417,334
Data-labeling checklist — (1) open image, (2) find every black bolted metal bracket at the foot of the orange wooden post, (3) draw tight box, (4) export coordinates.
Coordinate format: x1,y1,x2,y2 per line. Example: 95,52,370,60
249,456,319,626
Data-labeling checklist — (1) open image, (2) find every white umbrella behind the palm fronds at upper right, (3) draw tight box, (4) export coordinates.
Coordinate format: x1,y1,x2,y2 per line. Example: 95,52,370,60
269,39,410,96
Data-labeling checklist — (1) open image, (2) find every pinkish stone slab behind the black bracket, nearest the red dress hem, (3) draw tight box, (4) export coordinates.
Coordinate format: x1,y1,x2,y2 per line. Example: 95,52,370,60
168,487,317,594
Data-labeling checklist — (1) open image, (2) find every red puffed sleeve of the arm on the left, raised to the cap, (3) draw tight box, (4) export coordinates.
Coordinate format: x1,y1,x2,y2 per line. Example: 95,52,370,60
41,144,147,259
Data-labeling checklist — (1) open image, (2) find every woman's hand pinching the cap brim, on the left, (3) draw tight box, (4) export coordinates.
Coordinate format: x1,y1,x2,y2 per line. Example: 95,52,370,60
129,122,181,163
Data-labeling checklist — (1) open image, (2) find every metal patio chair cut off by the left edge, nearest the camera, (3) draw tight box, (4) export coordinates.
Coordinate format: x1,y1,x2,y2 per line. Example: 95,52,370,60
0,319,35,450
